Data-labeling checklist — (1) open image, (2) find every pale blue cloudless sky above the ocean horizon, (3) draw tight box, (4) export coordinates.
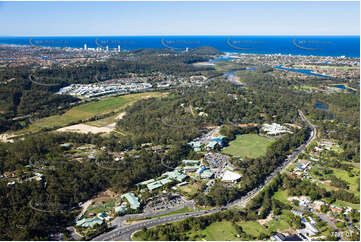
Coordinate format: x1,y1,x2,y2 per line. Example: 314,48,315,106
0,2,360,36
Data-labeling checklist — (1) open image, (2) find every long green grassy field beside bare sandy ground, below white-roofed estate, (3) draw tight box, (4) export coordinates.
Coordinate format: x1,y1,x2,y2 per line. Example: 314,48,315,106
13,92,163,134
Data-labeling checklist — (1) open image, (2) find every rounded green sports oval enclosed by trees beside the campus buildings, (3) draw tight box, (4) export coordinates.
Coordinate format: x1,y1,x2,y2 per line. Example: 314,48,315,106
223,134,276,158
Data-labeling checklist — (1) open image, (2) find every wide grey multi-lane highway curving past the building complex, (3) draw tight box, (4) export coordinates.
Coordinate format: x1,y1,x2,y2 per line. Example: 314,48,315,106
93,110,317,241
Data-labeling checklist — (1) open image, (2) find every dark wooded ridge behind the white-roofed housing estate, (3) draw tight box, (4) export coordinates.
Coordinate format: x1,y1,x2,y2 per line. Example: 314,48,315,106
0,47,217,132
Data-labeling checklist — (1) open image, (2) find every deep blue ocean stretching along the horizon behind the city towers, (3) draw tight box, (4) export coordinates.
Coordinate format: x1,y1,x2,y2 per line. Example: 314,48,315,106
0,36,360,57
